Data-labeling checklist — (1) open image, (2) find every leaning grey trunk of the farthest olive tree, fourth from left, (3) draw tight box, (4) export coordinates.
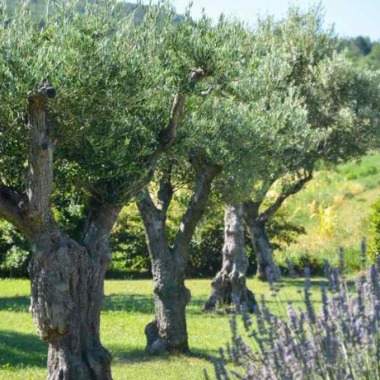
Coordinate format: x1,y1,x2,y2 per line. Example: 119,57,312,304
244,201,281,281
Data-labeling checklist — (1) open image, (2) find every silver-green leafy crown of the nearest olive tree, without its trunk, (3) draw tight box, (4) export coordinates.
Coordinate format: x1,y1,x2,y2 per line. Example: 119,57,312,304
0,1,256,202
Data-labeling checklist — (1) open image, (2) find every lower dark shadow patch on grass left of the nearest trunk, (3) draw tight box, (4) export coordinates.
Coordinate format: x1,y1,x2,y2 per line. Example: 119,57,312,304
0,330,47,368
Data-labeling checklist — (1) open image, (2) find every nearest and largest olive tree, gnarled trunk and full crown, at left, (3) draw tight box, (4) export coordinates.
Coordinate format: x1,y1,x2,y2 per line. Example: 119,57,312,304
0,1,215,380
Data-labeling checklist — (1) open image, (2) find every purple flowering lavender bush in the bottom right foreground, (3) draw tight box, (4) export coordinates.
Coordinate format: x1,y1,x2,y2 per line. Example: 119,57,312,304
215,260,380,380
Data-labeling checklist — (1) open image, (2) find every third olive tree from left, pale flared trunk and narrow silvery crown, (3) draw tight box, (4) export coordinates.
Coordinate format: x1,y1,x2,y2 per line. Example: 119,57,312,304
205,8,317,311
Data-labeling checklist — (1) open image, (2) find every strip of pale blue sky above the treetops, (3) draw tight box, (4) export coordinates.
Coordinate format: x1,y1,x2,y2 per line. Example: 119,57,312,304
142,0,380,41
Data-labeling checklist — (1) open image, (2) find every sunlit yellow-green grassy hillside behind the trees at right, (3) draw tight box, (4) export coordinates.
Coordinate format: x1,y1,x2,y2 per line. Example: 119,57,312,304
276,153,380,271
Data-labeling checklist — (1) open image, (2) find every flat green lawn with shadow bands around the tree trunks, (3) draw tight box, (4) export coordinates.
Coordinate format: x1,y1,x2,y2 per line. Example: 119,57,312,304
0,279,326,380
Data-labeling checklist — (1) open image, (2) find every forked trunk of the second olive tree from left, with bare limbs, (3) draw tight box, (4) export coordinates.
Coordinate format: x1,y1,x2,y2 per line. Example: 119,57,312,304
137,165,220,354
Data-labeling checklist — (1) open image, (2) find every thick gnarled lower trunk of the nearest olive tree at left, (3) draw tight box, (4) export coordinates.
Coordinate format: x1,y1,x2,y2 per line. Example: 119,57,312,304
29,205,117,380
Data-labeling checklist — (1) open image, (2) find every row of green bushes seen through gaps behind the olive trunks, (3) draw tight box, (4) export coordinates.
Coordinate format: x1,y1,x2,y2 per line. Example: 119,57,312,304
0,194,304,278
